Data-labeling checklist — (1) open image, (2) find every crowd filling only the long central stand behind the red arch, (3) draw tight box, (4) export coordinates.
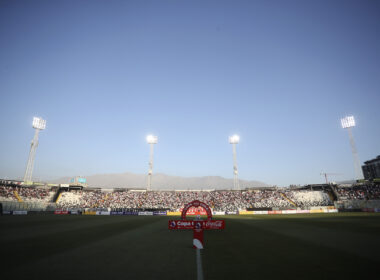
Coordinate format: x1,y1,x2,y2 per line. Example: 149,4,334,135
57,190,331,212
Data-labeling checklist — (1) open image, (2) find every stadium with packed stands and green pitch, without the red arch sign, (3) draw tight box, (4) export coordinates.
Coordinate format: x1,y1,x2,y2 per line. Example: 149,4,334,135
0,180,380,279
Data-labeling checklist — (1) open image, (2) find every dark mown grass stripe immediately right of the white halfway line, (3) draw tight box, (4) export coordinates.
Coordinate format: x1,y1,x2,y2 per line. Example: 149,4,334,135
203,217,379,279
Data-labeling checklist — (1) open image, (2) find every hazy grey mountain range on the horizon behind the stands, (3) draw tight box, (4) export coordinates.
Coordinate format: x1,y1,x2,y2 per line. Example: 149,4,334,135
54,172,270,190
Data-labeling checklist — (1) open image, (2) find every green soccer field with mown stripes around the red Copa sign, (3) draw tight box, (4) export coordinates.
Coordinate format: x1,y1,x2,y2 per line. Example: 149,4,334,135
0,213,380,279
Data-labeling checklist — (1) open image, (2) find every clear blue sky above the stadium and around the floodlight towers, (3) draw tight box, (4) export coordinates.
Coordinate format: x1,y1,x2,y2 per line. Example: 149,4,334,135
0,0,380,186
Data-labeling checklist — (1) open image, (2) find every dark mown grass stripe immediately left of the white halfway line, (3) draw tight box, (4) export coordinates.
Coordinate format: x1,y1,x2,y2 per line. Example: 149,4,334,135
2,217,196,280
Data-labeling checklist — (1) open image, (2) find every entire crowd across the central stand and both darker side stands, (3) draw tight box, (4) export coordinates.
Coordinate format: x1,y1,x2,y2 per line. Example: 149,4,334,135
0,185,380,212
